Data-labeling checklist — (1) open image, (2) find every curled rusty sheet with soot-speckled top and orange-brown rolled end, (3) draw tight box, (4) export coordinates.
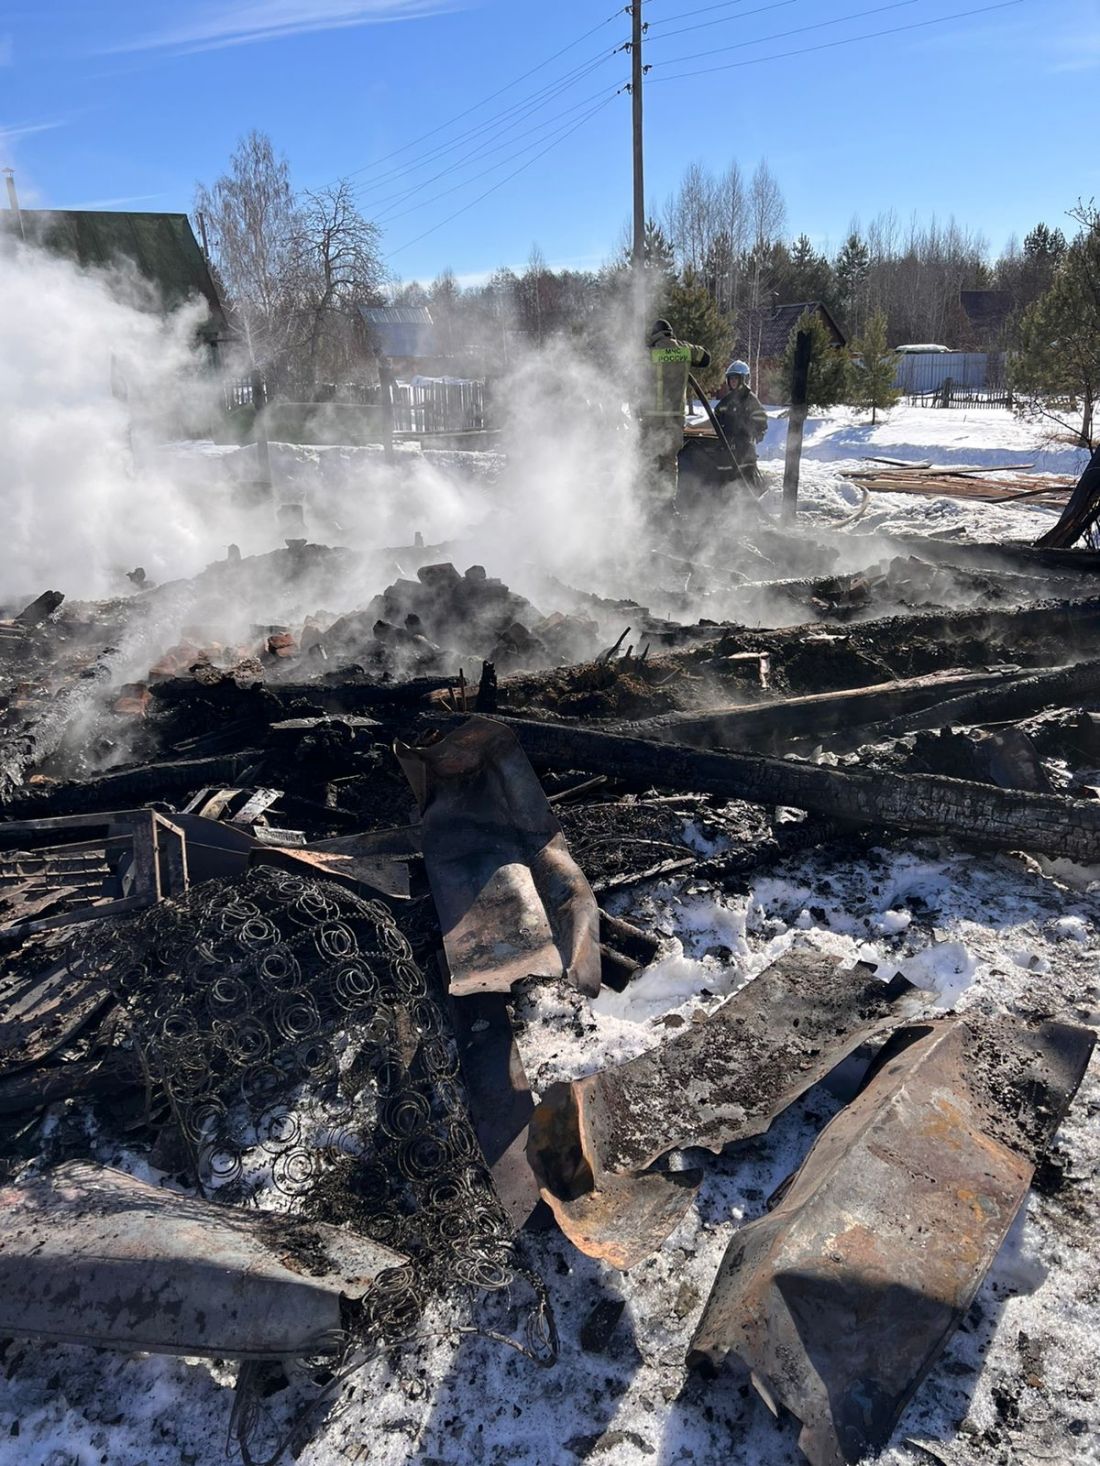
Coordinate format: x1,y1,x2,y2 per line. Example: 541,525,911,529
528,949,925,1268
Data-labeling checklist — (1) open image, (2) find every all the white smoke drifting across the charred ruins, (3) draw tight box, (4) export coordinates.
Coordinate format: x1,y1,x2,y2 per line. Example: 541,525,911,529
0,246,997,647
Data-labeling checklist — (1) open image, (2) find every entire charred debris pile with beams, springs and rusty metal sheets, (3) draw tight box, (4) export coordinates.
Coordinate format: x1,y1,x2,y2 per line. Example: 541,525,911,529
0,527,1100,1466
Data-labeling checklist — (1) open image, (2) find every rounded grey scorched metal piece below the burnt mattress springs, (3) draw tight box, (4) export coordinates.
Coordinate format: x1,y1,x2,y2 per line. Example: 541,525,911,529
0,1161,405,1359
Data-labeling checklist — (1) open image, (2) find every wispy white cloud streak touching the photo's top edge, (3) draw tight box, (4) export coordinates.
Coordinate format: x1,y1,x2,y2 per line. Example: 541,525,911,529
104,0,461,53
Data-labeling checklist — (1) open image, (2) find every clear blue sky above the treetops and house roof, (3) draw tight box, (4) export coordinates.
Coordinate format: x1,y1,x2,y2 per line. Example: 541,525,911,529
0,0,1100,279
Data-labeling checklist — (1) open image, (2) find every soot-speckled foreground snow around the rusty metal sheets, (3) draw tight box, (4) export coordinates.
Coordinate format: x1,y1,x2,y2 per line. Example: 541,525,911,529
0,841,1100,1466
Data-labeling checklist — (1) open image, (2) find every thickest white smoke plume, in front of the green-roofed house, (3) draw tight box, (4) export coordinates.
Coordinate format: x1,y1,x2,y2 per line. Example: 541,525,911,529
0,246,228,597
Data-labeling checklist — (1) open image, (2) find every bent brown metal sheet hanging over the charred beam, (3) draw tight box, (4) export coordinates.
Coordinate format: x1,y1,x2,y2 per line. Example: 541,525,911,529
395,718,600,995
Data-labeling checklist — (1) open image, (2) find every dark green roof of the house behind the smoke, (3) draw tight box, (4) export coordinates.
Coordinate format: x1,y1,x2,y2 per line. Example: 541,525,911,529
0,208,224,325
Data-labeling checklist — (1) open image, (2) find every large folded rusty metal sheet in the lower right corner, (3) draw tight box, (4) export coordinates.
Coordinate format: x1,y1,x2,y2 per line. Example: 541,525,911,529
689,1019,1096,1466
